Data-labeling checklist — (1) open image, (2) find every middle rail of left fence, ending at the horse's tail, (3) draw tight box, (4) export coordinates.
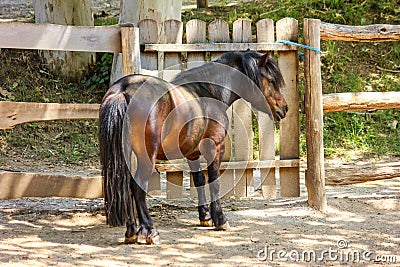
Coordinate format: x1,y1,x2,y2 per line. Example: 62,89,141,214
0,101,100,129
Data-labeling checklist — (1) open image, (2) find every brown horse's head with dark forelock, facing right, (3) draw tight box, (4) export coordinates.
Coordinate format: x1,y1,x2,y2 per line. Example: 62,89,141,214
254,53,288,121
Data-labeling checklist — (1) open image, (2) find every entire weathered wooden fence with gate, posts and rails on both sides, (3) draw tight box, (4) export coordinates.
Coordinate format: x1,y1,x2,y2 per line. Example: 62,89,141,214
0,18,400,210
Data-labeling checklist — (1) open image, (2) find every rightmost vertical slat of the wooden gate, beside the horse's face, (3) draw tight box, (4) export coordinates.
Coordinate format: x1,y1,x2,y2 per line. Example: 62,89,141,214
276,18,300,197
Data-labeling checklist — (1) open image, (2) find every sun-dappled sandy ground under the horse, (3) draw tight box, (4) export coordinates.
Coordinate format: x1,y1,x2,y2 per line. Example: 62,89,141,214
0,174,400,266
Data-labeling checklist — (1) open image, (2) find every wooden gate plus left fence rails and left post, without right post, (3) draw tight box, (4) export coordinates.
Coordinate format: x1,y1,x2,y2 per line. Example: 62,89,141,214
0,18,300,199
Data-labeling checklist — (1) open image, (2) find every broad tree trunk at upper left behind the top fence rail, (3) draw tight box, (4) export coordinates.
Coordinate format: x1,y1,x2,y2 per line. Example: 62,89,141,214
34,0,95,79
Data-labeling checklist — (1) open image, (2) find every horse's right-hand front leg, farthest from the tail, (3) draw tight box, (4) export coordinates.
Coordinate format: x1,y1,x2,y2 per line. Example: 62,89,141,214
208,142,229,230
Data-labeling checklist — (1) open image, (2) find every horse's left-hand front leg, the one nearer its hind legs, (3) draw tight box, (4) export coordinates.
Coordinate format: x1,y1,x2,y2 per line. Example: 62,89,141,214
189,159,212,227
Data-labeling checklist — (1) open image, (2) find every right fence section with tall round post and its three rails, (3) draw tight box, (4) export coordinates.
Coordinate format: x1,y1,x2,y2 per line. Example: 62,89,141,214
303,19,400,211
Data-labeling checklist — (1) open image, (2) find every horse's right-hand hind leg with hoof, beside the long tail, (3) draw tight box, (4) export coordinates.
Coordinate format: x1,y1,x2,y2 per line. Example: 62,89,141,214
131,164,160,245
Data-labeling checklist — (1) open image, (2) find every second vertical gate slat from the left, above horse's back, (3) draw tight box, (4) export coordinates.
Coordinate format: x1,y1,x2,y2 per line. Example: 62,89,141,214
159,19,183,81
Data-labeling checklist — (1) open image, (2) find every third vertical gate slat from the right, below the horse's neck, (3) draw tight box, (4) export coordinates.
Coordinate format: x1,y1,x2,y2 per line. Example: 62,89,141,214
232,20,253,198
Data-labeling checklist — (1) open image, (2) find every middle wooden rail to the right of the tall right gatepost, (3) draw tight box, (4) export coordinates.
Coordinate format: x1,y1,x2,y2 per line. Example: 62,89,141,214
323,92,400,113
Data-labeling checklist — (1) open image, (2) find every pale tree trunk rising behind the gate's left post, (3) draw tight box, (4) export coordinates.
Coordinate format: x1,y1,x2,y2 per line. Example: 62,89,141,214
110,0,182,83
